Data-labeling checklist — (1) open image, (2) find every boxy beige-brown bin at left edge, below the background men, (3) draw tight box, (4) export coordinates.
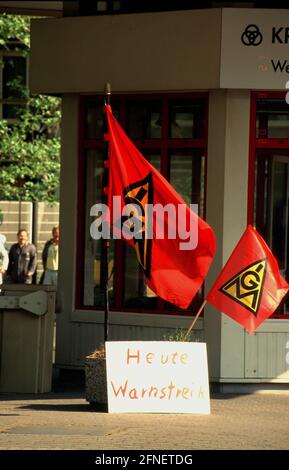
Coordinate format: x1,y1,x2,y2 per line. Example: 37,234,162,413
0,284,56,393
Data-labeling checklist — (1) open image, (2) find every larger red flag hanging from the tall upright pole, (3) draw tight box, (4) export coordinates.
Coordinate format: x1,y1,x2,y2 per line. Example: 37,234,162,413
105,105,215,309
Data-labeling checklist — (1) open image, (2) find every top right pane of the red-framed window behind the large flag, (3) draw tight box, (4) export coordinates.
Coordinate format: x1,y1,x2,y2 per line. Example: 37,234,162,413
169,99,206,139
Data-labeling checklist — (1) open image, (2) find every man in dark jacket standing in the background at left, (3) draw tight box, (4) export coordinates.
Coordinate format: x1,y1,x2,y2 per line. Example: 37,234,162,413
6,229,37,284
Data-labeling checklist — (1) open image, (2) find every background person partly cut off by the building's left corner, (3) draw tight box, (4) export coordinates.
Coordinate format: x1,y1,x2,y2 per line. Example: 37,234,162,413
42,225,59,286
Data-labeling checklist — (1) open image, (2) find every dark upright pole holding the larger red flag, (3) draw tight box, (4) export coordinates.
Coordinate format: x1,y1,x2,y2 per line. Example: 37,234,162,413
102,82,111,342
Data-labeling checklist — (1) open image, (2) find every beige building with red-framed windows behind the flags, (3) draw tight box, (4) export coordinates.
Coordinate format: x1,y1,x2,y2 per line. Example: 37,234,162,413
30,8,289,390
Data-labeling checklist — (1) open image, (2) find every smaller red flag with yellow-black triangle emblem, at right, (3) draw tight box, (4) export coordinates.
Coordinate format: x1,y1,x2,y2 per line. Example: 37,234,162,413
207,225,289,333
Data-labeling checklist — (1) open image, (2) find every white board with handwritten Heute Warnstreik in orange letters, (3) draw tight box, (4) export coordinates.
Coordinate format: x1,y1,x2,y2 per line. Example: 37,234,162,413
105,341,210,414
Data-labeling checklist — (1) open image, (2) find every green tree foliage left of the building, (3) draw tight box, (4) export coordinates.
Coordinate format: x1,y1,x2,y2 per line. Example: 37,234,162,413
0,15,61,203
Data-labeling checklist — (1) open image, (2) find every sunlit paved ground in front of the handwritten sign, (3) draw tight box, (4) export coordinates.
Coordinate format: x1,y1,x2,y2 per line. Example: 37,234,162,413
0,372,289,450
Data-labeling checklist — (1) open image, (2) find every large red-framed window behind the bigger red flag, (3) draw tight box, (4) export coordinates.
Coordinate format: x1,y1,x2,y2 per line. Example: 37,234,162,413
76,93,207,315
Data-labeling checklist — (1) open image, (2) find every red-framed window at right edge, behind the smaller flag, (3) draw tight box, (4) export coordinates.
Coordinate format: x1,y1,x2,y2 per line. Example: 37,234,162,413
249,92,289,318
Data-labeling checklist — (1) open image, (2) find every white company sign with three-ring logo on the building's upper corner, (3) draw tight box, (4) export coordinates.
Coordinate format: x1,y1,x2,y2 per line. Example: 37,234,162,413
220,8,289,90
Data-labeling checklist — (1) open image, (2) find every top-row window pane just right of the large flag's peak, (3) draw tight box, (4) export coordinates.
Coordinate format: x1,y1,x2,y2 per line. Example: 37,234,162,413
126,101,161,139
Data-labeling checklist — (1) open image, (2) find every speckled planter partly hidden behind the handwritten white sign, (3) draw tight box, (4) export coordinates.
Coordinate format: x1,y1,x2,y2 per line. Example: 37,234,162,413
85,356,107,405
